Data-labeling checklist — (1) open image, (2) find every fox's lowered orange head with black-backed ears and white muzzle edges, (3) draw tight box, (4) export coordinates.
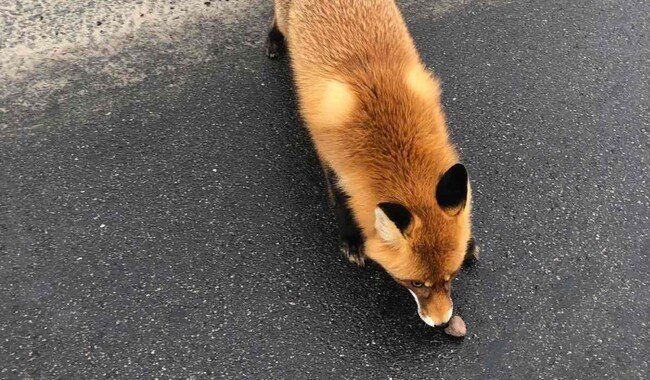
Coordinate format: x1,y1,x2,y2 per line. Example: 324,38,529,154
366,164,474,326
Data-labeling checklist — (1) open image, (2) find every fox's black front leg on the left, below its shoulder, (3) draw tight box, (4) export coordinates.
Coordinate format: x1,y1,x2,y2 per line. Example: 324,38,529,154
325,169,366,267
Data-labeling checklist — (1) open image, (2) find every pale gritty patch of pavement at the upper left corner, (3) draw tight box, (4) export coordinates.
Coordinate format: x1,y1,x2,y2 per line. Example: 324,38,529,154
0,0,270,107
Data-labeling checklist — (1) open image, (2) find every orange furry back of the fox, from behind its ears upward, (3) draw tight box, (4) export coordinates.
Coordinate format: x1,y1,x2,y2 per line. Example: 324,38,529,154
279,0,458,236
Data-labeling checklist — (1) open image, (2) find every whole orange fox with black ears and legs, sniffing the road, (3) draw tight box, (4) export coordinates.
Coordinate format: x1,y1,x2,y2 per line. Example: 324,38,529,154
266,0,478,327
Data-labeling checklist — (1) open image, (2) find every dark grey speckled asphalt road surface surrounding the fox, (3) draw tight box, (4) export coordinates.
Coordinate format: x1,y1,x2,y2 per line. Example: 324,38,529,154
0,0,650,379
